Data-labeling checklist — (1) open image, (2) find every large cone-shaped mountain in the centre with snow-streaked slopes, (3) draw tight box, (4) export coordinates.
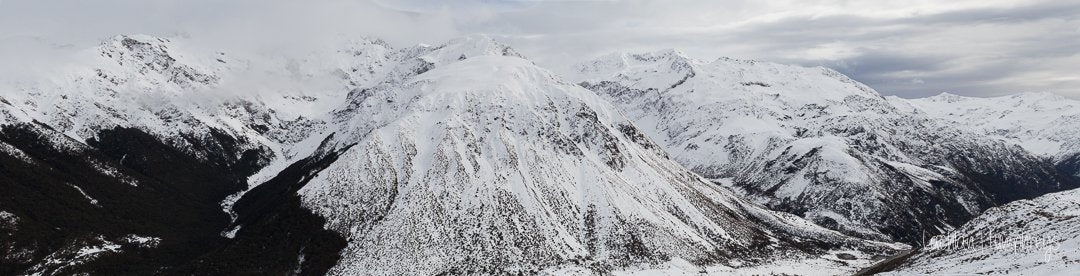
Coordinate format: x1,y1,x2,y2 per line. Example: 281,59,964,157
282,37,890,275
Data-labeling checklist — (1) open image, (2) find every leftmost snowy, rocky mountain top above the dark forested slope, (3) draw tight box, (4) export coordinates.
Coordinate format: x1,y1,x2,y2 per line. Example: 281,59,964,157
0,36,354,178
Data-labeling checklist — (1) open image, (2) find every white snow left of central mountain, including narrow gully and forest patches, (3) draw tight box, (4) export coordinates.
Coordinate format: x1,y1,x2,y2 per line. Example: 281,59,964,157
0,35,401,222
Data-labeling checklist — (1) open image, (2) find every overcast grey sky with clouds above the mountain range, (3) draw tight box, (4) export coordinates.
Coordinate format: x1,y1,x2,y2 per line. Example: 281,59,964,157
0,0,1080,98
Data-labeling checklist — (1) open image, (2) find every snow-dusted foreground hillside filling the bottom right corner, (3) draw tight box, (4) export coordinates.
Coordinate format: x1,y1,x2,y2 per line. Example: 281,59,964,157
887,186,1080,275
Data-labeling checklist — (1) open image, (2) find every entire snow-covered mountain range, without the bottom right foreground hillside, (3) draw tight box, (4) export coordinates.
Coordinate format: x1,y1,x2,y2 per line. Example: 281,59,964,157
8,36,1076,275
